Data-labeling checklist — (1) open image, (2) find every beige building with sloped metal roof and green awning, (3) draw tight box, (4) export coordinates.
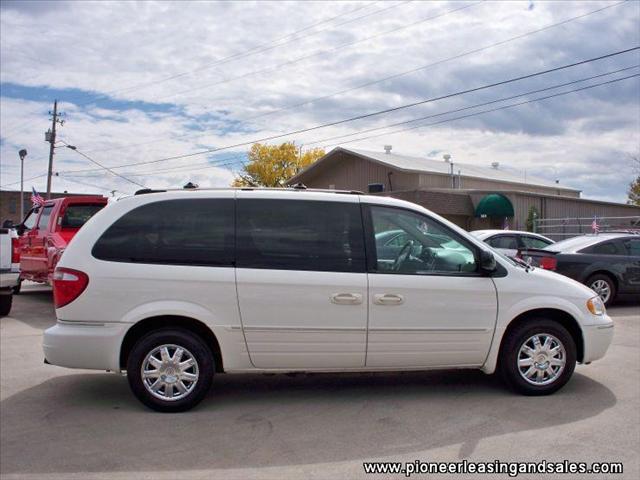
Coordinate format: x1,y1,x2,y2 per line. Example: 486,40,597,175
288,147,640,234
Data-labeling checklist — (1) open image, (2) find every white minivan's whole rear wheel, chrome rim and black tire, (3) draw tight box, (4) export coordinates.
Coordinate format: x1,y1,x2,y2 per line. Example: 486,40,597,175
127,328,215,412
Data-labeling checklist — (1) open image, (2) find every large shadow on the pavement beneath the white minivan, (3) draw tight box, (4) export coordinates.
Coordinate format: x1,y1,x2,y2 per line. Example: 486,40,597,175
0,371,616,474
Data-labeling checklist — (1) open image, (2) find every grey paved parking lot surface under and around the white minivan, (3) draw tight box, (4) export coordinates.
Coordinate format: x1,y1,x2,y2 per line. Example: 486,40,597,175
0,287,640,479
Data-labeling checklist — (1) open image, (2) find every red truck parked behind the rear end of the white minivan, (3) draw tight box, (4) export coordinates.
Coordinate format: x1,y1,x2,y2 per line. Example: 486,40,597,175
15,195,107,283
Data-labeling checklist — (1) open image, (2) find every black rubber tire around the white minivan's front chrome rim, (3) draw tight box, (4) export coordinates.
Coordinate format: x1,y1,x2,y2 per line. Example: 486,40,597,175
499,318,576,396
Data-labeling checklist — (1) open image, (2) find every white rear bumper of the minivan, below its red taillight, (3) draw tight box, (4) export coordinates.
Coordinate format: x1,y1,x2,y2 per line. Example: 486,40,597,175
42,321,131,372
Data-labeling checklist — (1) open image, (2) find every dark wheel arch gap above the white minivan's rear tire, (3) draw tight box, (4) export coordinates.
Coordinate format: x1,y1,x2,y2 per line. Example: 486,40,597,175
120,315,224,373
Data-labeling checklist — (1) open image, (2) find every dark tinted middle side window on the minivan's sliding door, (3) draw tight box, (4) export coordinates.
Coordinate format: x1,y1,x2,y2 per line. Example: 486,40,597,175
236,199,366,272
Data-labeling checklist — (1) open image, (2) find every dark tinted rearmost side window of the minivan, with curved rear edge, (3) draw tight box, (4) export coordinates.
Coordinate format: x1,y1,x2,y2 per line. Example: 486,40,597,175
92,199,235,267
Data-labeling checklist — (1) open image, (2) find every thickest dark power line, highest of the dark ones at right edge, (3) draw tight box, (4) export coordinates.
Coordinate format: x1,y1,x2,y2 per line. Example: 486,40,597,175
60,47,640,172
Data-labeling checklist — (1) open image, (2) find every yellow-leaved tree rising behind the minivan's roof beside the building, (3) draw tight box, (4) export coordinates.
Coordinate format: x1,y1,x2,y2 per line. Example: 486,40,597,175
232,142,324,187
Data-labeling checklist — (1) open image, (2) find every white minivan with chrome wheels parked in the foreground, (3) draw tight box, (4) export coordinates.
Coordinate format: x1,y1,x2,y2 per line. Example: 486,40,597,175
44,189,613,412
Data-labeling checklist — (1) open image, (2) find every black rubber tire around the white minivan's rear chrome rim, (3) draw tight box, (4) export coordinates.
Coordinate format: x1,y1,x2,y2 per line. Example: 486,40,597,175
127,328,215,412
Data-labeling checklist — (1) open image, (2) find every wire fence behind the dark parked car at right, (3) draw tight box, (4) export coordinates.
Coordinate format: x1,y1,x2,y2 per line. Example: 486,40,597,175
533,215,640,240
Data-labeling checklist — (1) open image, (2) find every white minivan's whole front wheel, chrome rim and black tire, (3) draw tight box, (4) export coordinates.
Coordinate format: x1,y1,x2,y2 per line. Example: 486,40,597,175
500,318,576,395
